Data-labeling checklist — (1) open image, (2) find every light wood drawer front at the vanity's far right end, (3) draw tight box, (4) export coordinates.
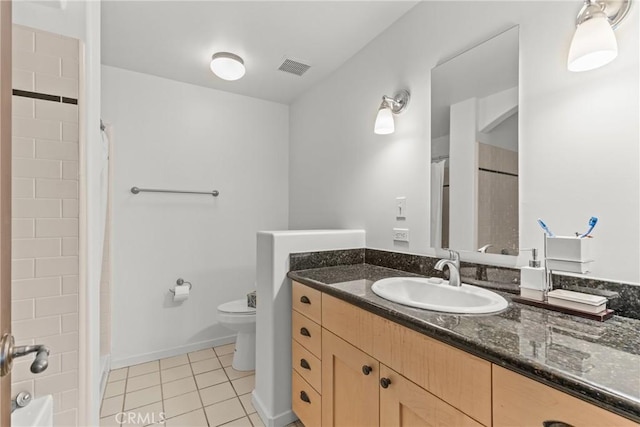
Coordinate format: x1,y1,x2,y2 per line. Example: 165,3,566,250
493,365,638,427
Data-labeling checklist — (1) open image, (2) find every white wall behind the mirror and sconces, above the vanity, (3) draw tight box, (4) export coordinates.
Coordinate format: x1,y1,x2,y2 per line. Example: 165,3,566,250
289,1,640,283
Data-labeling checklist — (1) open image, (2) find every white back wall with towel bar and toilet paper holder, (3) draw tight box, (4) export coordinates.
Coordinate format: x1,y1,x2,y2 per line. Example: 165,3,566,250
102,66,289,366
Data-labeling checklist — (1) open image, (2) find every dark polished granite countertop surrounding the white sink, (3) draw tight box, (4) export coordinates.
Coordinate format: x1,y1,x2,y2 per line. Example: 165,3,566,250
288,264,640,422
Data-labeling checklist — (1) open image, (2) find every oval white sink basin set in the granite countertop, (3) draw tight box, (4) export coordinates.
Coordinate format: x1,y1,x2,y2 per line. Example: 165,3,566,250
371,277,509,314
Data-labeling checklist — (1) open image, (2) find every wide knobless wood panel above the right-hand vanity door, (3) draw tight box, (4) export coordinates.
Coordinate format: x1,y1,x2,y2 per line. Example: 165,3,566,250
371,316,491,426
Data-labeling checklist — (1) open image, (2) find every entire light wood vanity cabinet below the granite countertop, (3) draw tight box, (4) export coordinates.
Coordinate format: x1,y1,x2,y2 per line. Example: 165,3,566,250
292,282,638,427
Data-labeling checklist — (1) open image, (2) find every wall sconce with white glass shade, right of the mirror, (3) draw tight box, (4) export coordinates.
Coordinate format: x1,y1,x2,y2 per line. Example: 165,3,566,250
567,0,631,71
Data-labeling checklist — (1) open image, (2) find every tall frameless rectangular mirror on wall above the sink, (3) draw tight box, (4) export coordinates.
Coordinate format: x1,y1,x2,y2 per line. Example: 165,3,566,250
431,26,519,255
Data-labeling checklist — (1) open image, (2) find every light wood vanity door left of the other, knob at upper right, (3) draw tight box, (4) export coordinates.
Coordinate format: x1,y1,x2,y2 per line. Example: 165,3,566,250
322,329,379,427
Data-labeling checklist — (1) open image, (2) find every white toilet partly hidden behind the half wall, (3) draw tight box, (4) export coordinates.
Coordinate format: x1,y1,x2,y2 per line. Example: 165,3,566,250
218,298,256,371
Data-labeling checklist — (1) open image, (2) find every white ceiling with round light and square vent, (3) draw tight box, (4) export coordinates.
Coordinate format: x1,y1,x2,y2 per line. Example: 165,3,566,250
102,0,417,104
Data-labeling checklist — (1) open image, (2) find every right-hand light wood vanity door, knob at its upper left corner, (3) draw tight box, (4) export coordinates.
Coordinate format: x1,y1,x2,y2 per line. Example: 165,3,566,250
380,364,482,427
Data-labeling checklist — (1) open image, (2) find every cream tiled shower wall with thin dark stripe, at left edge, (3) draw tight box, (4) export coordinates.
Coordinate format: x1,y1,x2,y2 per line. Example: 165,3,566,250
12,25,79,427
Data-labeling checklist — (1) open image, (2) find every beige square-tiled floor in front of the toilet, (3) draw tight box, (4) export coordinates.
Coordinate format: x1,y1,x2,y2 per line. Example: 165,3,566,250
100,344,304,427
